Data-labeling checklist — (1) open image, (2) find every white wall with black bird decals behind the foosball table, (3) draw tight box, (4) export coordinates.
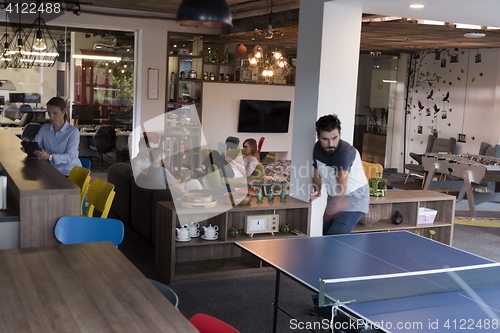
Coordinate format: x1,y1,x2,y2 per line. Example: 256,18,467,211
400,49,500,159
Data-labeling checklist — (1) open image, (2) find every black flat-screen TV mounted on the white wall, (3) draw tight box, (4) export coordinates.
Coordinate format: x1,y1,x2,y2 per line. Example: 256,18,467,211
238,99,291,133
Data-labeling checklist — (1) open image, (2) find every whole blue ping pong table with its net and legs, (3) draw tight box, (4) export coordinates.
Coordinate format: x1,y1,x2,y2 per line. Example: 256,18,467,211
236,231,500,333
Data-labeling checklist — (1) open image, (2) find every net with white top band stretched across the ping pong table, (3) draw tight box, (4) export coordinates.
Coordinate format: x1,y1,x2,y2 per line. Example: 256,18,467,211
318,263,500,306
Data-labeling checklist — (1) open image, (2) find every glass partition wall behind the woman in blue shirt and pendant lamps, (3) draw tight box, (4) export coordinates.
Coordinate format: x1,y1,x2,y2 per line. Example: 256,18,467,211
0,22,135,129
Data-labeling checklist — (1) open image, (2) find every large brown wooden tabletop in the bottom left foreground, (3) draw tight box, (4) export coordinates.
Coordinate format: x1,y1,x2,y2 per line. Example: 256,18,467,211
0,242,198,333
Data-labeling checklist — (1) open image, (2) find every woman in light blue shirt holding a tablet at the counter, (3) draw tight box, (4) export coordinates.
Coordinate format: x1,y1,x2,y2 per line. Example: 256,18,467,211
34,97,82,176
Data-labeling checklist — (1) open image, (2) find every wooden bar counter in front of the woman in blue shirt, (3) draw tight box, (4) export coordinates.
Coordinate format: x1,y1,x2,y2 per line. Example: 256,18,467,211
0,130,80,247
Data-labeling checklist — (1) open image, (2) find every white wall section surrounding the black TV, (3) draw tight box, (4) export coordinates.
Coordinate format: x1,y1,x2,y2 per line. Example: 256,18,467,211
202,82,295,159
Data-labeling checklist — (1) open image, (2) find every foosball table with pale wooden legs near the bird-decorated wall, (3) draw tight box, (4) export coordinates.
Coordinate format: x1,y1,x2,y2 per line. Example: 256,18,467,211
422,154,500,218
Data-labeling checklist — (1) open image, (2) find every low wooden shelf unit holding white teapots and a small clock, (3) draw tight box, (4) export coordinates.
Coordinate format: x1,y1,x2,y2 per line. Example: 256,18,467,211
155,197,310,283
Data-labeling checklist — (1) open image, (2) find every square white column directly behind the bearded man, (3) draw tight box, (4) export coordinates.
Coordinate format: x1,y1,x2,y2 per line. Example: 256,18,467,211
291,1,362,236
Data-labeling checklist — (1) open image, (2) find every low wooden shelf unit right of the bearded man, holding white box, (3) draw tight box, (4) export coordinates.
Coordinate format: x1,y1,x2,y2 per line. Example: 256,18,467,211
352,190,455,245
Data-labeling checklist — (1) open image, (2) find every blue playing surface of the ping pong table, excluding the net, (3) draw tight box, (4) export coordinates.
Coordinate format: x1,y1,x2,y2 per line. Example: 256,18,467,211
236,231,500,332
